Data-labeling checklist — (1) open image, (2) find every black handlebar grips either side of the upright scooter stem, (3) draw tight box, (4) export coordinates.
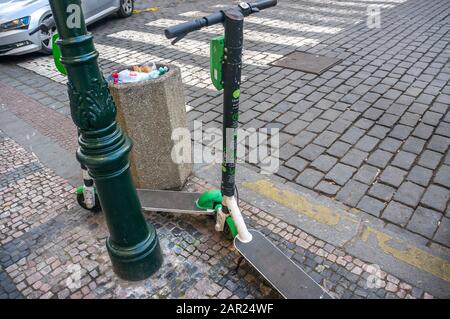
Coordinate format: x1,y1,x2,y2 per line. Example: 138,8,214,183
164,0,278,39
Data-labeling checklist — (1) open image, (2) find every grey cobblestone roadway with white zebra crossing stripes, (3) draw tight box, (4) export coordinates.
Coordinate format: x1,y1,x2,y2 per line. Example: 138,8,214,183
0,0,450,247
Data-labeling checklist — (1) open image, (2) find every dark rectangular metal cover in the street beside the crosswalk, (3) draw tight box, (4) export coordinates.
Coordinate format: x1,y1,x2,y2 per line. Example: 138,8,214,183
271,51,342,75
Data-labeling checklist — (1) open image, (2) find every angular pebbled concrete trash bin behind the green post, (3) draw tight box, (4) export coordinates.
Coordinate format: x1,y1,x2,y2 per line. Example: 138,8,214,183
109,65,192,189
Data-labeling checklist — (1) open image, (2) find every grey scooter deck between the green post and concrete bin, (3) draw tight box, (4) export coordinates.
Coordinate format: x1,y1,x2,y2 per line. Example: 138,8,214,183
137,189,214,215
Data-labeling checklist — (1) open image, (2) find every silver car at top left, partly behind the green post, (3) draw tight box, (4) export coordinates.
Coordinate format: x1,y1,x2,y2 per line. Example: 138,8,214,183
0,0,134,56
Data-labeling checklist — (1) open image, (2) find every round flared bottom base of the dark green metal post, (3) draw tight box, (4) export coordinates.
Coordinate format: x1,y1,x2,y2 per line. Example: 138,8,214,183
106,225,163,281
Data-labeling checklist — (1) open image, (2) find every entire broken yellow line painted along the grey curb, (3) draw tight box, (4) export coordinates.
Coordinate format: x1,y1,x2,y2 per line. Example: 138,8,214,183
242,179,450,282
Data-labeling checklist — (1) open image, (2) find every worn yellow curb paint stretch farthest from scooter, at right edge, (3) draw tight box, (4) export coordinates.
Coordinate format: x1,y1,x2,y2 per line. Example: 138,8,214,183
361,227,450,282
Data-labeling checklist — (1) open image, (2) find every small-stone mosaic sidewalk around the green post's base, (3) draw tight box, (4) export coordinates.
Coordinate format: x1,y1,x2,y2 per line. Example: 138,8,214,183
0,130,432,299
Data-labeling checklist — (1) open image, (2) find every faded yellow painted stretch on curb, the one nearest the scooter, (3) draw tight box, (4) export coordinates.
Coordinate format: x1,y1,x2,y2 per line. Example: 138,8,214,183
243,179,340,226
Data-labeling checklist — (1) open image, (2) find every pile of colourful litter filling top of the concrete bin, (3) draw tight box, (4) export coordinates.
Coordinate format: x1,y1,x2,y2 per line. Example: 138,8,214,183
108,62,169,84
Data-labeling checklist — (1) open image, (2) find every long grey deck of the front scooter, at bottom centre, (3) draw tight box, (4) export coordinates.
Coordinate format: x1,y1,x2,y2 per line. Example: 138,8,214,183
234,230,331,299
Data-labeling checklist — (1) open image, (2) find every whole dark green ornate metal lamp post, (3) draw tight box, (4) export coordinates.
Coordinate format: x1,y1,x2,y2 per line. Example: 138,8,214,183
50,0,163,280
